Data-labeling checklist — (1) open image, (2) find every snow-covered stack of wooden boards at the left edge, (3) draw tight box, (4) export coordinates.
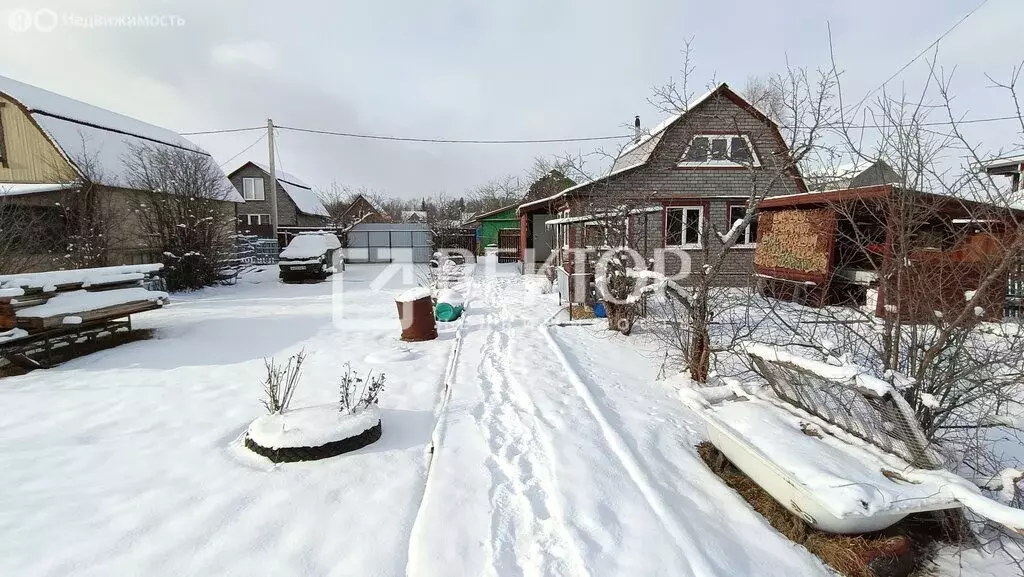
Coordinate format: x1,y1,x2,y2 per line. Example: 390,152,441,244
0,264,168,344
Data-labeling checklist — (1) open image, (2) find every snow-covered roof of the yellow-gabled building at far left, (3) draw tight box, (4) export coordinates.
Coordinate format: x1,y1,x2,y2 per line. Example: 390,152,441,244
0,76,243,202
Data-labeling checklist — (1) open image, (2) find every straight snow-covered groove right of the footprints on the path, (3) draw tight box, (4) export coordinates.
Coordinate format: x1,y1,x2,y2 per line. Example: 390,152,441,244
538,317,721,576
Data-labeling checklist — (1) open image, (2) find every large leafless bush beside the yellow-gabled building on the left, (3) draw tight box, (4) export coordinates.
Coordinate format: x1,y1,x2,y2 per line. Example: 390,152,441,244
123,145,233,290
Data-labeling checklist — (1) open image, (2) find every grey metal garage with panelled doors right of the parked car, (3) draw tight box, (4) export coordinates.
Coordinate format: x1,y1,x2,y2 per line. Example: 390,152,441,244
344,222,433,263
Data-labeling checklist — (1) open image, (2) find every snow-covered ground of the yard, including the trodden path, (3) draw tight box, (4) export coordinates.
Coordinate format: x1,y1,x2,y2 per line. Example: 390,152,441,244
0,265,1015,576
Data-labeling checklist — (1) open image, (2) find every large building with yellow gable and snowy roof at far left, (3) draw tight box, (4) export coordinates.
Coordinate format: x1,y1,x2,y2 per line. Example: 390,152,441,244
0,77,242,269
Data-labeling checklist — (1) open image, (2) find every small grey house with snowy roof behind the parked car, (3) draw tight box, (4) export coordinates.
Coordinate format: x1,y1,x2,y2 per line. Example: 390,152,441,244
228,161,330,236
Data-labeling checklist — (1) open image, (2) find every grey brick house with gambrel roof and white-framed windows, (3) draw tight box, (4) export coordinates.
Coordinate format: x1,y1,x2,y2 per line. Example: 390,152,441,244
518,83,807,285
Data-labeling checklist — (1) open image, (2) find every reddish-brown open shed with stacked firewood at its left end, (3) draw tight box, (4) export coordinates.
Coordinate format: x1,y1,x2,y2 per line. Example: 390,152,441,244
754,186,1024,321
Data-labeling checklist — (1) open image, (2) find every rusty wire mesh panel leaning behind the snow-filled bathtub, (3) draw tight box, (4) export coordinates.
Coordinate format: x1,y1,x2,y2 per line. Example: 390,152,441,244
751,354,941,468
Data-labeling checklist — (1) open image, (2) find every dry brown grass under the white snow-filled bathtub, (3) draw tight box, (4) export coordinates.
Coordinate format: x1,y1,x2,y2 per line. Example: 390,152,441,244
697,441,945,577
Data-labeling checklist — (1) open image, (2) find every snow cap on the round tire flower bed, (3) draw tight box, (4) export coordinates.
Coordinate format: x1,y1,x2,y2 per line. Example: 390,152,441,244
246,403,385,449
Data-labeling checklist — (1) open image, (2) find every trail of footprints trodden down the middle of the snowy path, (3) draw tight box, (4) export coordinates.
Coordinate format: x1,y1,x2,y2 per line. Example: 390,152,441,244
474,280,586,576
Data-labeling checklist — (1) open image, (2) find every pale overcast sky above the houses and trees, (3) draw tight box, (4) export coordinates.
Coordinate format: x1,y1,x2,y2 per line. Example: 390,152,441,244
0,0,1024,198
